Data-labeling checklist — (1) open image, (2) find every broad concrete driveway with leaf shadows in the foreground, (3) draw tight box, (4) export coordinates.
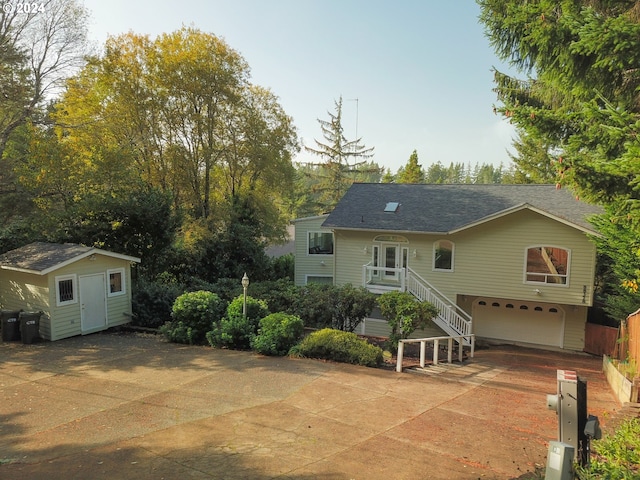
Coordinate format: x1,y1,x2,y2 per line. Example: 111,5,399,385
0,333,620,480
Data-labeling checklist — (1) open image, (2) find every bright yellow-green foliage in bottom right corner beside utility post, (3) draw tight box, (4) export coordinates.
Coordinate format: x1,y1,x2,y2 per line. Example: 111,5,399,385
576,418,640,480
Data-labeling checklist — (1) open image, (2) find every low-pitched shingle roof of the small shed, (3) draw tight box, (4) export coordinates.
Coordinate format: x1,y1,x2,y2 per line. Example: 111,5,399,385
0,242,140,275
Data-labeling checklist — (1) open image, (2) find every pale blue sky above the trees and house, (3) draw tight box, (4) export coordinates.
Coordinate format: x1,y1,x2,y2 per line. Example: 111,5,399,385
84,0,514,173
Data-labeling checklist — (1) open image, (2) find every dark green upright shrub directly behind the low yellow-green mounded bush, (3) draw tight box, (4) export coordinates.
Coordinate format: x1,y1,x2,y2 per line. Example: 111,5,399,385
331,284,376,332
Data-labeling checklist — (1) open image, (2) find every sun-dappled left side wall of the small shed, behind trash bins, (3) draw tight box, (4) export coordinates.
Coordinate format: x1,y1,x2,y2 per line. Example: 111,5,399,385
0,270,51,339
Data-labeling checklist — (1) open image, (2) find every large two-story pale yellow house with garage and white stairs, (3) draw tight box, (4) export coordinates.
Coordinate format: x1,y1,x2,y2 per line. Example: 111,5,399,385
294,183,602,351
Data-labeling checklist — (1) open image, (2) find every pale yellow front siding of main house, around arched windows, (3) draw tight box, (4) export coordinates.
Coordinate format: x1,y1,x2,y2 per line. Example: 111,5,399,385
334,210,596,351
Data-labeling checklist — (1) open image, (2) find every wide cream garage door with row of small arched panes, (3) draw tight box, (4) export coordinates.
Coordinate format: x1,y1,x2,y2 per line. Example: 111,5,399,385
473,298,564,347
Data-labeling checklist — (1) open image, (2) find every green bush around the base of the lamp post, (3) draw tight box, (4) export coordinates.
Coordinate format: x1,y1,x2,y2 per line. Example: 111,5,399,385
206,295,269,350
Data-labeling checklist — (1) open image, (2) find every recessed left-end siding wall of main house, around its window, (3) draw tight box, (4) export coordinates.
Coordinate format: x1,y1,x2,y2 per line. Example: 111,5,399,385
294,215,337,285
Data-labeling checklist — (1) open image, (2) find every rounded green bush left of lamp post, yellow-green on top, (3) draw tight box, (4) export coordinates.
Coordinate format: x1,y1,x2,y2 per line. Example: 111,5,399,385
160,290,226,345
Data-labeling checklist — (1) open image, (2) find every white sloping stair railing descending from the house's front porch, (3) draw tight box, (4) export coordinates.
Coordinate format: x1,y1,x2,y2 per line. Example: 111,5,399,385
406,268,472,345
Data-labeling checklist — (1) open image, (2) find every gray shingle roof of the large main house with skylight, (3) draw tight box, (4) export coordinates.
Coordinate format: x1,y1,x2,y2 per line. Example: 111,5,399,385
323,183,603,233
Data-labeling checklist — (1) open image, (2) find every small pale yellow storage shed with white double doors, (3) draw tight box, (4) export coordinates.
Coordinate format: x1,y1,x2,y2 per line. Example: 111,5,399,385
0,242,140,340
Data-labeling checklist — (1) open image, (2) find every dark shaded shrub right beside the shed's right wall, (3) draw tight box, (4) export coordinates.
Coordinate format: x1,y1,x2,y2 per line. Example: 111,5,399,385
131,277,184,328
